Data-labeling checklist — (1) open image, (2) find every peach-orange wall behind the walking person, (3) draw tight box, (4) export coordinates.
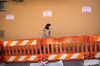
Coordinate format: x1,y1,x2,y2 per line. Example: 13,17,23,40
1,0,100,39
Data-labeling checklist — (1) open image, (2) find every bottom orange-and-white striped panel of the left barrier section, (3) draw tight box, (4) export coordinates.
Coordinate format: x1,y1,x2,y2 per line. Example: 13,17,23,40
5,55,38,62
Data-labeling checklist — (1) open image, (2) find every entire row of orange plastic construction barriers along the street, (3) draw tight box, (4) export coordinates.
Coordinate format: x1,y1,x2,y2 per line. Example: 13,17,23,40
1,35,100,62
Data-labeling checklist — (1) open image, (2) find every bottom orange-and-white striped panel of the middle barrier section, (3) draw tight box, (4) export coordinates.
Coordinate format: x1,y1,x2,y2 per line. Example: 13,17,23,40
48,53,84,61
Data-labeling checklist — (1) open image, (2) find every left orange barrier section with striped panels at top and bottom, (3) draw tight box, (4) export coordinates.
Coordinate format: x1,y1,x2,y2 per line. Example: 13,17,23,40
4,39,41,62
